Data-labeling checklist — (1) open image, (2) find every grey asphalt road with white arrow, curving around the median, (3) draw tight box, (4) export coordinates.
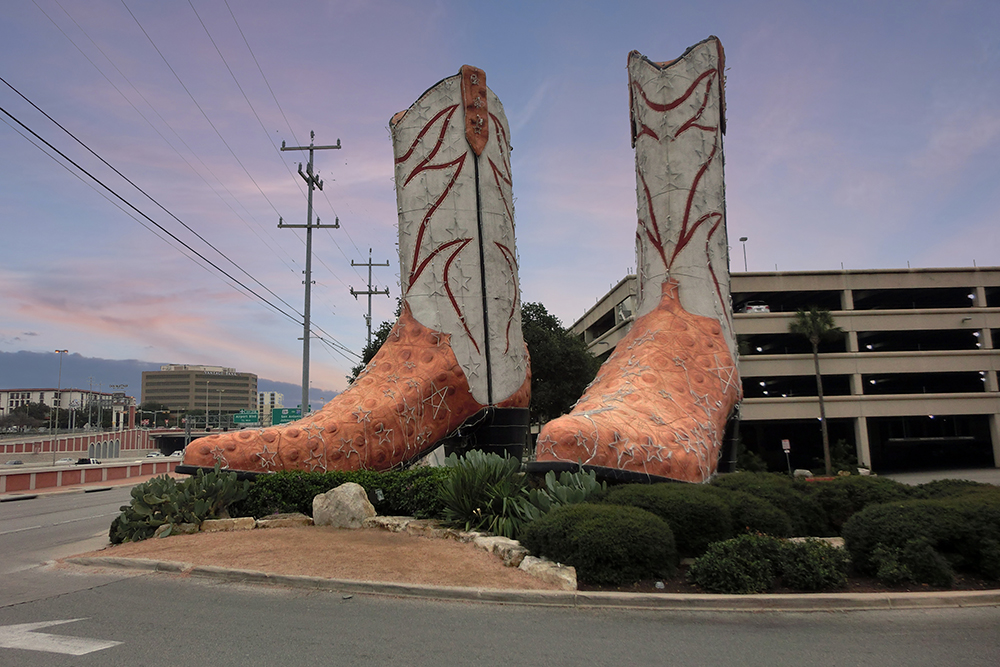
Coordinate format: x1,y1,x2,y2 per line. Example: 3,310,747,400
0,489,1000,667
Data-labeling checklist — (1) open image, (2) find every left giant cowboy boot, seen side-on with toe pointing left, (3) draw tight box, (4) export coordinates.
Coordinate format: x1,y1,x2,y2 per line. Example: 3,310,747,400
184,66,531,472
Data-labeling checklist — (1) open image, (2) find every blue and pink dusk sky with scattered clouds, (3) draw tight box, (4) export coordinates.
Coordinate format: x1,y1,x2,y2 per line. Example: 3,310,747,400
0,0,1000,391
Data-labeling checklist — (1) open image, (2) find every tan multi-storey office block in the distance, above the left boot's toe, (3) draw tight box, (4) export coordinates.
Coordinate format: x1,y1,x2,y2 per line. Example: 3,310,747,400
142,364,257,413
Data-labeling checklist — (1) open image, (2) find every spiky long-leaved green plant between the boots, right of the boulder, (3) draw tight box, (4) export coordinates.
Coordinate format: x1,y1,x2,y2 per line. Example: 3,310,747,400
441,450,527,538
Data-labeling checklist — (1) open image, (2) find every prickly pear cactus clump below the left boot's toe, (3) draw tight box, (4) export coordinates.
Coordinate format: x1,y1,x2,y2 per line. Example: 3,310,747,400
108,466,250,544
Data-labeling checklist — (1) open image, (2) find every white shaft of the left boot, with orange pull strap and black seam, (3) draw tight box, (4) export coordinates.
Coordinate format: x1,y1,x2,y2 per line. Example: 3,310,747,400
390,66,528,405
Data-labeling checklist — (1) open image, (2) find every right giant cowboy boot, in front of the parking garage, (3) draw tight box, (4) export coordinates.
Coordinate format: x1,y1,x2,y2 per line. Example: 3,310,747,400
530,37,742,482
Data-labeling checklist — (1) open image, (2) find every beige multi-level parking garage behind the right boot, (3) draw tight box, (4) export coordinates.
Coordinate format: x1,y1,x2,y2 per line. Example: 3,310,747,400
570,267,1000,471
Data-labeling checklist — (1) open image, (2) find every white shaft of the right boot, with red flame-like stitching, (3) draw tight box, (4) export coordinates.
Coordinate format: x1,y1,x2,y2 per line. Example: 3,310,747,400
628,37,736,358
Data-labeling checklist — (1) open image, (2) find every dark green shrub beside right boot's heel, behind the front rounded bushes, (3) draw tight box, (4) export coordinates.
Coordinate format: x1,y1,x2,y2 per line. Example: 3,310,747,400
712,472,834,537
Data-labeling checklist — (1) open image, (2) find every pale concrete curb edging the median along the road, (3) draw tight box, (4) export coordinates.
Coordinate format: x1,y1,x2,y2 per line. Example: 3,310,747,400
62,556,1000,612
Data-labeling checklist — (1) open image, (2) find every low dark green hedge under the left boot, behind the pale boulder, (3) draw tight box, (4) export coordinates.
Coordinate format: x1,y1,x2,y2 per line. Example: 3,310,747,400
230,467,451,519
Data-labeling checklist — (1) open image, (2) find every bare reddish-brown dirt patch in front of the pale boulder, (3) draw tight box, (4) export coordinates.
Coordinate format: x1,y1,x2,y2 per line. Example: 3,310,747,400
81,526,557,590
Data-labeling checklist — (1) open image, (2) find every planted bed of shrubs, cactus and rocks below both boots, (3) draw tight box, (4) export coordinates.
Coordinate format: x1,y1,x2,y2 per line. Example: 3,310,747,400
88,453,1000,604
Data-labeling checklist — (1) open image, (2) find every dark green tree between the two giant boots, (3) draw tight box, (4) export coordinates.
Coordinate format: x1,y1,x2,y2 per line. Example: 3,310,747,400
521,303,601,423
